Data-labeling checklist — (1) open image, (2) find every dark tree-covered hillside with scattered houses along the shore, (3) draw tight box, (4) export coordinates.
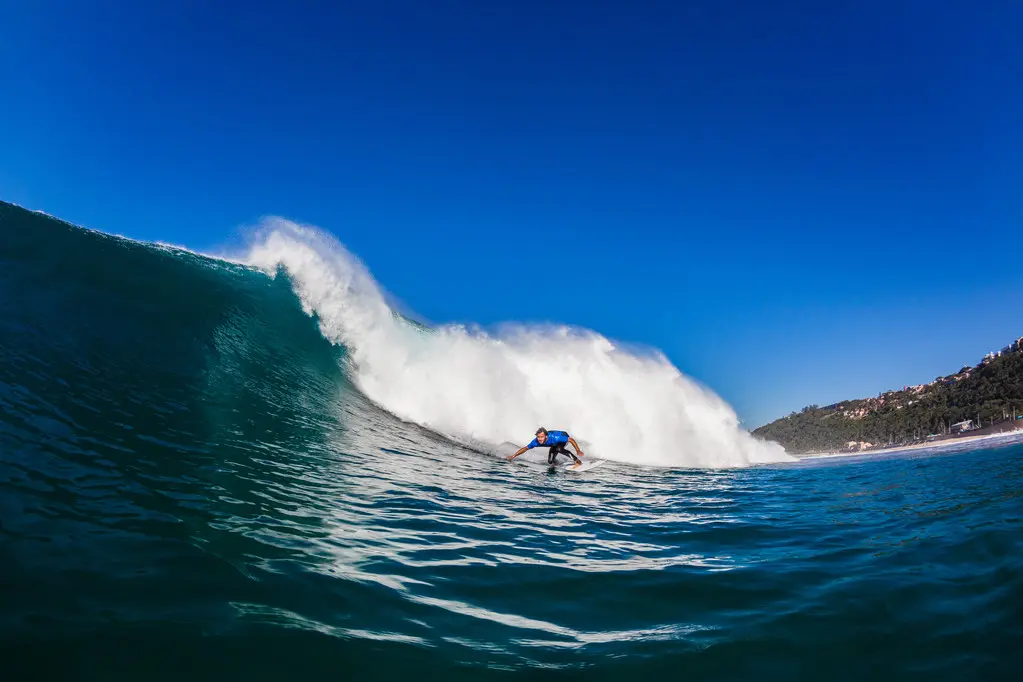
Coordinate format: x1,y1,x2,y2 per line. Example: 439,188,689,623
753,340,1023,453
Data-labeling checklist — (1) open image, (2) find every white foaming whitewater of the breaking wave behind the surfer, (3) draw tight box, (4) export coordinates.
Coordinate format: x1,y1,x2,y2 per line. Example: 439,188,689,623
246,219,791,467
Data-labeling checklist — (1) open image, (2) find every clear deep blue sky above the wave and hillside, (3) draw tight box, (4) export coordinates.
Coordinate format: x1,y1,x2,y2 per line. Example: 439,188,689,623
0,0,1023,425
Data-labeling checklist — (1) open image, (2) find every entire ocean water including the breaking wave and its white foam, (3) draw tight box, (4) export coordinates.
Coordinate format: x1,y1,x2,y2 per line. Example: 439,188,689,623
0,203,1023,680
